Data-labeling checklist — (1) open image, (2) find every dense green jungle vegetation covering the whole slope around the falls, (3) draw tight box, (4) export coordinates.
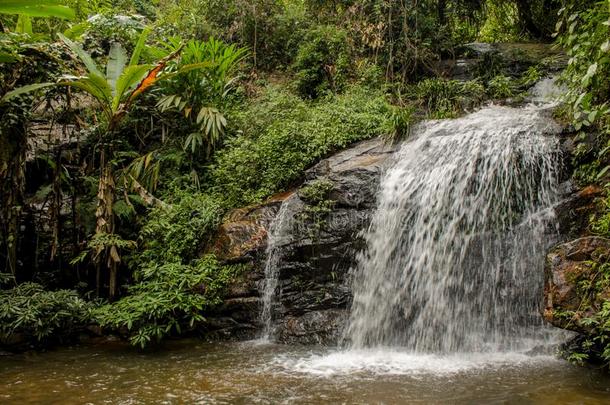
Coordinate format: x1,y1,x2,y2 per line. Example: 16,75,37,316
0,0,610,362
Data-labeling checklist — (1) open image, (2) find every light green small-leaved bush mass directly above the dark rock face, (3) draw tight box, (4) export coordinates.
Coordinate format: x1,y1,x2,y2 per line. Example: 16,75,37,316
210,87,390,207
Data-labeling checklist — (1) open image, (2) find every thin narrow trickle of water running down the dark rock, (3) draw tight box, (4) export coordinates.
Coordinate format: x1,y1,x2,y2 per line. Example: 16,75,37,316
260,201,291,342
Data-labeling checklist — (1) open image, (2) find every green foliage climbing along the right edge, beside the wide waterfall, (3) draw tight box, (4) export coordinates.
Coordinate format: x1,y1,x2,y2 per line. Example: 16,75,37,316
557,1,610,367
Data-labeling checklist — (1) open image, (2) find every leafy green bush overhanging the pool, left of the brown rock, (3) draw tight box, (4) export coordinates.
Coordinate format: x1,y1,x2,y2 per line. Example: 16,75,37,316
94,191,239,347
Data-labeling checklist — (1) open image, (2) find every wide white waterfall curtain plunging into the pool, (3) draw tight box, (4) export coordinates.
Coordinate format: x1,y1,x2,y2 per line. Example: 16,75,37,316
346,106,562,353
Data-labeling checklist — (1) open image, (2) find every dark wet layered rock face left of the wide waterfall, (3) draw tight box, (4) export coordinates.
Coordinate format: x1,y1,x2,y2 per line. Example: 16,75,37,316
202,139,395,344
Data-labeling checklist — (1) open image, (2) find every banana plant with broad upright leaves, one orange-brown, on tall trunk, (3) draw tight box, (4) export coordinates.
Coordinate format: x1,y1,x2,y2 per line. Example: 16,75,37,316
0,30,208,300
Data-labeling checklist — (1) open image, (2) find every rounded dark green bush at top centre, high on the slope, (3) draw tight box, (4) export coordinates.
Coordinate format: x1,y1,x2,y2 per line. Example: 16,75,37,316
293,26,350,99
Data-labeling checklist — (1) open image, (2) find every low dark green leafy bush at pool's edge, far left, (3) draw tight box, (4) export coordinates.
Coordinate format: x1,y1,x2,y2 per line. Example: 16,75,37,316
0,283,90,345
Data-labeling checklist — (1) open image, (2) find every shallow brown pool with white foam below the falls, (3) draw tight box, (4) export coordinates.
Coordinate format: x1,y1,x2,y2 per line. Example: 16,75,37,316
0,340,610,404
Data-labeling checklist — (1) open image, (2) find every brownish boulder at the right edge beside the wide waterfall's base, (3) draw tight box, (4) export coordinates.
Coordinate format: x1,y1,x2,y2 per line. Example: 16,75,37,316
544,236,610,334
